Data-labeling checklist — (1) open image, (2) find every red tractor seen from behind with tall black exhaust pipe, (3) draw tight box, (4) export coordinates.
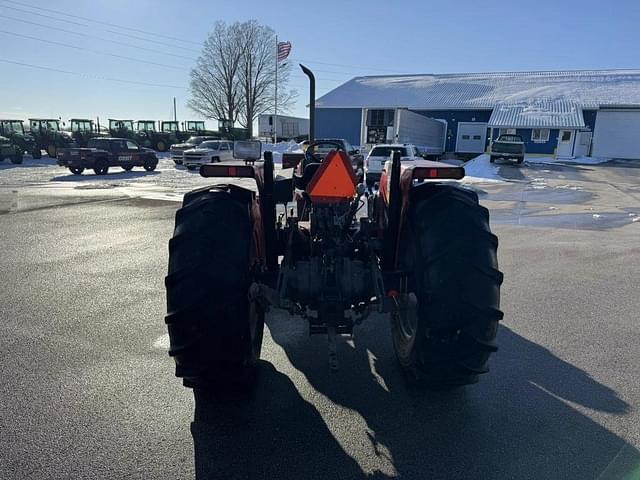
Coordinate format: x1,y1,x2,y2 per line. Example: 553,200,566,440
165,67,503,390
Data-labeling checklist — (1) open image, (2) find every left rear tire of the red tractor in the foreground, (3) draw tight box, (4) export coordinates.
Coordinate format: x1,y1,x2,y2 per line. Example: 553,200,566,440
165,189,264,392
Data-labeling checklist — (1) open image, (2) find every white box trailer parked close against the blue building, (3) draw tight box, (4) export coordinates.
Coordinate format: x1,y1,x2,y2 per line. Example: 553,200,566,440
362,108,447,157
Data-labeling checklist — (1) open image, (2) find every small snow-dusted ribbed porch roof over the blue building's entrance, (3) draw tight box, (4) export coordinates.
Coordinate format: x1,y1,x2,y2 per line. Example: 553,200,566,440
489,100,585,128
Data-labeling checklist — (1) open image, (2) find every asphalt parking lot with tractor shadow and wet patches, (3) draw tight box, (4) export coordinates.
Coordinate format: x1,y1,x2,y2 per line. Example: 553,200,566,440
0,157,640,480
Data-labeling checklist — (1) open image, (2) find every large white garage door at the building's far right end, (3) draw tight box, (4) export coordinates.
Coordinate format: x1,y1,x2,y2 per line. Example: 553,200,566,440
592,110,640,159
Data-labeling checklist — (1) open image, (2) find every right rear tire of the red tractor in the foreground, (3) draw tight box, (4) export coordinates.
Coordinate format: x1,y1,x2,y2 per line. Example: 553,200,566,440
392,184,503,390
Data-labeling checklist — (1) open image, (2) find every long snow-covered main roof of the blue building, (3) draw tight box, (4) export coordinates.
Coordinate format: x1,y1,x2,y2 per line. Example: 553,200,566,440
316,69,640,110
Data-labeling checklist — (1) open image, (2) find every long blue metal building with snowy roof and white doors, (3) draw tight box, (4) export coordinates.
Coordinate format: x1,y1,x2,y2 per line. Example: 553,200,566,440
316,70,640,158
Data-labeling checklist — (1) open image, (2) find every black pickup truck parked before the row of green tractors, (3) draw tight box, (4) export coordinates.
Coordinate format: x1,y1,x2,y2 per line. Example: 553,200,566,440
57,138,158,175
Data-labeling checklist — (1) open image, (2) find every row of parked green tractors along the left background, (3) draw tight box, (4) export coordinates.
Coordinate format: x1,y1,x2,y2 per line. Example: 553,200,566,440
0,118,246,164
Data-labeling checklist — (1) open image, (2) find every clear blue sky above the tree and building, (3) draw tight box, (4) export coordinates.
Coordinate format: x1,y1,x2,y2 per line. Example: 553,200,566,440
0,0,640,129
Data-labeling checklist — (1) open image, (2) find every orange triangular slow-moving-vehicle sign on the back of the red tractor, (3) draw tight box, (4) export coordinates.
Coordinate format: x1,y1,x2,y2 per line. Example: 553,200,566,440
307,150,357,203
